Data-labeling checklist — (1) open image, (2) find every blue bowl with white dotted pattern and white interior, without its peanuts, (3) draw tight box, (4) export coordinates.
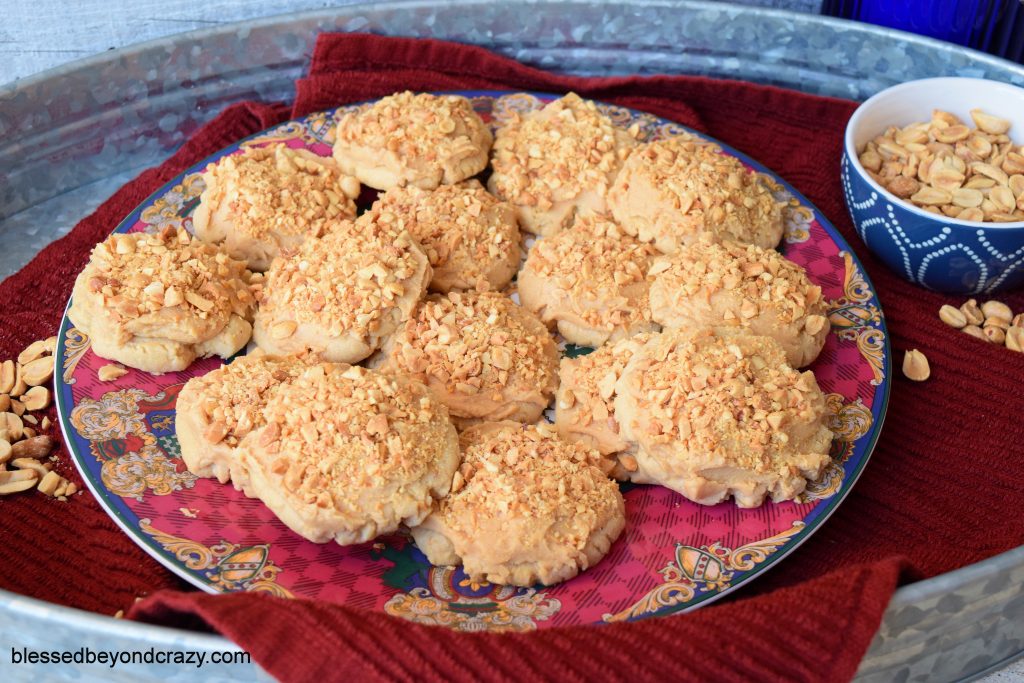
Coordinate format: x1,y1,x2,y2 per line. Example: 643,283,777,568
842,78,1024,294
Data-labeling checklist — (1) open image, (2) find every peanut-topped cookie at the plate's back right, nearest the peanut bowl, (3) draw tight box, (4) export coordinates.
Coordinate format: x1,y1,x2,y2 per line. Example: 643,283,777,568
608,136,783,254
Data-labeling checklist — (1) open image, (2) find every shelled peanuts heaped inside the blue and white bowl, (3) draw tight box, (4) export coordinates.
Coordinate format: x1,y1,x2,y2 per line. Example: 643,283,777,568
859,110,1024,223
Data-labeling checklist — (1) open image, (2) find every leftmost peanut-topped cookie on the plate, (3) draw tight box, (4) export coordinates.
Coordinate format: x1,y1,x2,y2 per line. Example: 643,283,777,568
68,228,255,374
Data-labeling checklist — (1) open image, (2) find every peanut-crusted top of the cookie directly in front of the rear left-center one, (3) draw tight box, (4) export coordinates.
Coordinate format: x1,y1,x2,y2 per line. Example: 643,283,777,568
372,180,519,292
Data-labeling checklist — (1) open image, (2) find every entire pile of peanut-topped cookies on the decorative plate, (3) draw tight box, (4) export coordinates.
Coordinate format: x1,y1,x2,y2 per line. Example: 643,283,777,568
70,92,831,586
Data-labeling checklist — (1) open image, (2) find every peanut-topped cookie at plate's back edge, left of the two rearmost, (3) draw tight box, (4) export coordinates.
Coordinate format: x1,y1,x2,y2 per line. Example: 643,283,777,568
334,91,493,189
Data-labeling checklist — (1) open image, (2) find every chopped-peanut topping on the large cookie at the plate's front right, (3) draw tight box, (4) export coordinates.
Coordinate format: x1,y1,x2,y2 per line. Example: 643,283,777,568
615,330,823,472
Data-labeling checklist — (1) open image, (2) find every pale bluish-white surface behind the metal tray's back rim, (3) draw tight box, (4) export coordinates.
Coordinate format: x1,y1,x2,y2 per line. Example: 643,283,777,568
0,0,821,84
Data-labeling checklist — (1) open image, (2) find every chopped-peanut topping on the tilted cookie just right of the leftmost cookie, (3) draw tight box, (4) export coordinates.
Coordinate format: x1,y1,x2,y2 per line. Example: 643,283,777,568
260,214,426,338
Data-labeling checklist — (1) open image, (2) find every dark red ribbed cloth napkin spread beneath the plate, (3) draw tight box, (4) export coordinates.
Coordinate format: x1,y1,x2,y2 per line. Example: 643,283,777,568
0,35,1024,681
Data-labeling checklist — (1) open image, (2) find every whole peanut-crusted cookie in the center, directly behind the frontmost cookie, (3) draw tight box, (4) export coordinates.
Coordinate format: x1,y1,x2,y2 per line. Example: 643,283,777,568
383,292,558,427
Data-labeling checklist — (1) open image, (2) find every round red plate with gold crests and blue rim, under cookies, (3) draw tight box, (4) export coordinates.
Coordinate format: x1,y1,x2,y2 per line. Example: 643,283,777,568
55,92,891,631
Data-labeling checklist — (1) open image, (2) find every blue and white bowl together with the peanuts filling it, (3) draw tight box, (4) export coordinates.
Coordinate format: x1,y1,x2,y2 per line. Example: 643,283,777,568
842,78,1024,294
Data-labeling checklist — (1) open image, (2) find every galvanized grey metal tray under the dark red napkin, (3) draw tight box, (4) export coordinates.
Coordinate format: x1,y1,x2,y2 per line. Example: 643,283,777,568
0,0,1024,681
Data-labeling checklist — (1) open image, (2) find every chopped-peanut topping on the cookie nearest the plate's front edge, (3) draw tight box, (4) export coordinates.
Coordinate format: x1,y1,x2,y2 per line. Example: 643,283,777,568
438,422,618,532
